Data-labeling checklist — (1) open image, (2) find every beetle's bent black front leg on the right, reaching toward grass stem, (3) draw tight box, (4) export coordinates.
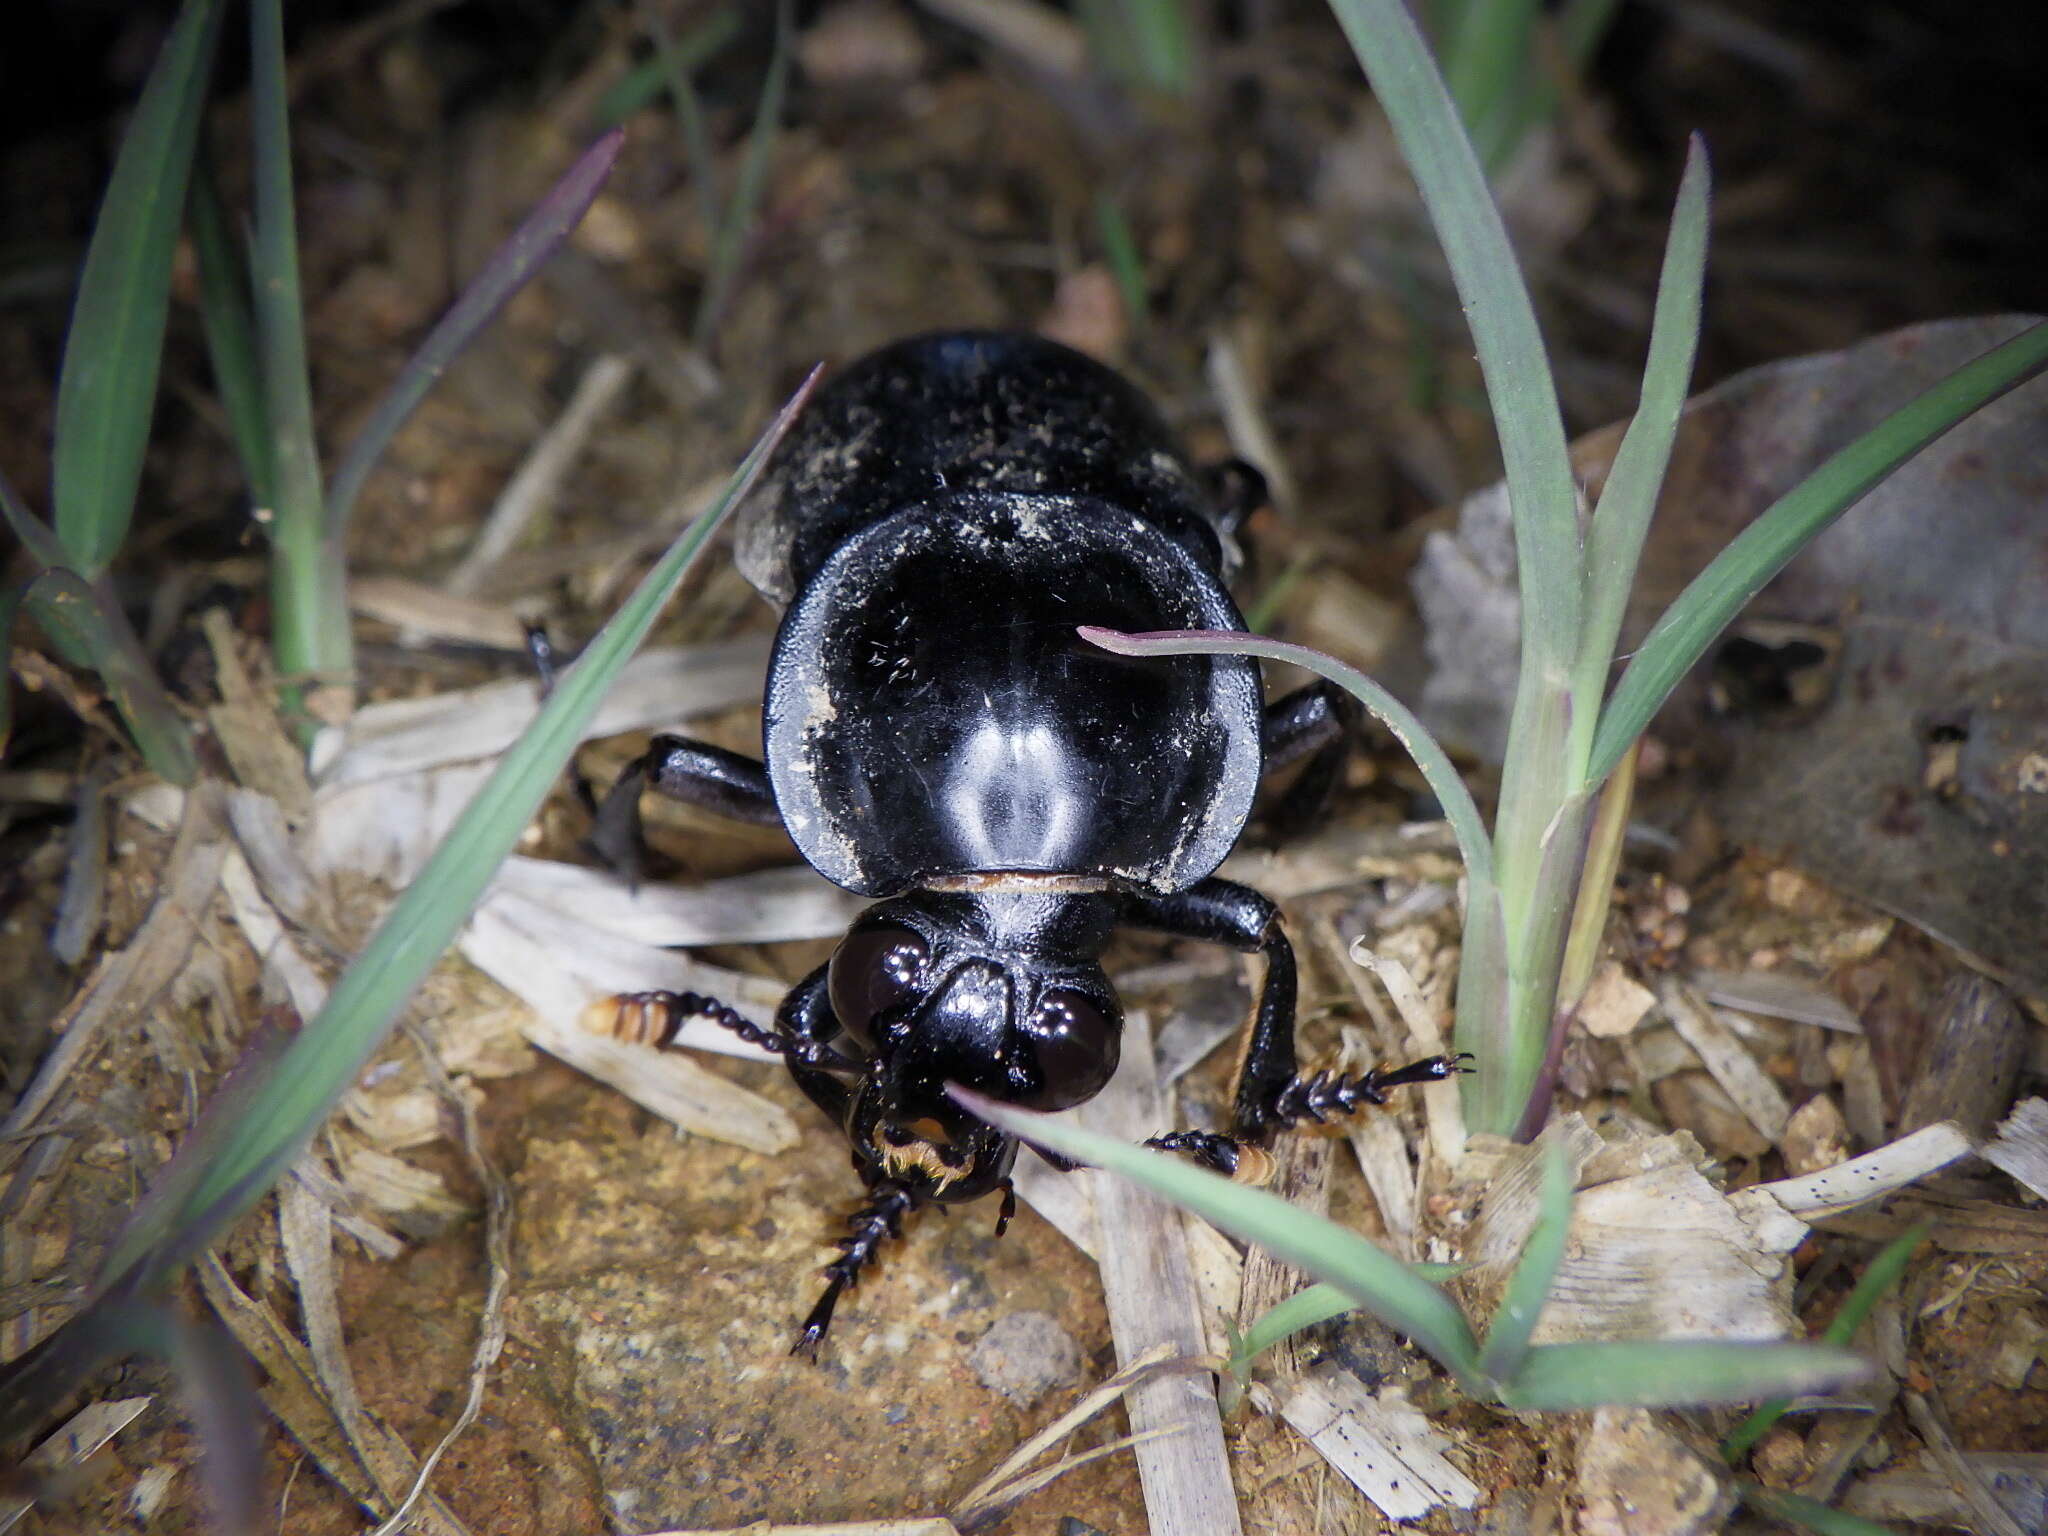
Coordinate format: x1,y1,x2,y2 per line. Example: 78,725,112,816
1122,877,1464,1171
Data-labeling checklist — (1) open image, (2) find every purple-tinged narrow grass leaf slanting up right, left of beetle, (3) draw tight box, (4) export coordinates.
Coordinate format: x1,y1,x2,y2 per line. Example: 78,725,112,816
328,129,625,539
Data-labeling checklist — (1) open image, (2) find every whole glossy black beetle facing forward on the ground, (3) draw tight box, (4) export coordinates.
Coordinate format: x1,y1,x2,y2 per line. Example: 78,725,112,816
594,332,1460,1354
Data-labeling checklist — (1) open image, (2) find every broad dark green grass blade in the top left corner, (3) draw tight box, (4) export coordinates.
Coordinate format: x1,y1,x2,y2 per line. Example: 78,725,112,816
51,0,221,578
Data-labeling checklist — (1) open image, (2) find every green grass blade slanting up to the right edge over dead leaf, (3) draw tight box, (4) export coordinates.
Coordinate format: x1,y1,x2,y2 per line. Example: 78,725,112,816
1587,322,2048,782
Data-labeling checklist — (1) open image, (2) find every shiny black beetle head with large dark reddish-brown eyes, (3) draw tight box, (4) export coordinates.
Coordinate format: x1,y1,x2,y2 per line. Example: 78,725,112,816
829,891,1122,1200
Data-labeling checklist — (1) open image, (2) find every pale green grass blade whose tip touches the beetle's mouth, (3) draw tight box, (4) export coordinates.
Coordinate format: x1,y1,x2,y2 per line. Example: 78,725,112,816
948,1087,1479,1380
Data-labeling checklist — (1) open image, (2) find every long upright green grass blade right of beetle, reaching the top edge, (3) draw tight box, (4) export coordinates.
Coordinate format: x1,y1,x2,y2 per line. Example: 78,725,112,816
1331,0,1581,672
